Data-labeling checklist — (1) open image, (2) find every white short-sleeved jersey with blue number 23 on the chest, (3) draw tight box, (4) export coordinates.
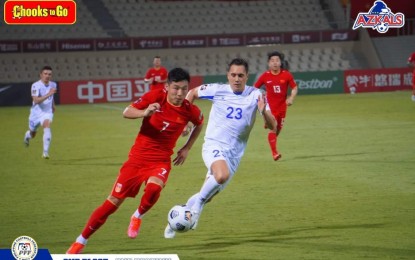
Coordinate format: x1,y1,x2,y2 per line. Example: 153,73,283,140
198,83,261,158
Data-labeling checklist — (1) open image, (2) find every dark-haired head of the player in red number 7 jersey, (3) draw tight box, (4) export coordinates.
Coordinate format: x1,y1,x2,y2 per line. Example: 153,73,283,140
166,68,190,106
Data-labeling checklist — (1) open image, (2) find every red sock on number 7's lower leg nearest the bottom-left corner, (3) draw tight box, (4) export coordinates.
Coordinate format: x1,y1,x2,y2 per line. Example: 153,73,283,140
82,200,118,239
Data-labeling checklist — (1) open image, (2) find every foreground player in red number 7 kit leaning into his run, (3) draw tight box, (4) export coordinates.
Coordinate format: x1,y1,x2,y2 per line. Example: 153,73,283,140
66,68,203,254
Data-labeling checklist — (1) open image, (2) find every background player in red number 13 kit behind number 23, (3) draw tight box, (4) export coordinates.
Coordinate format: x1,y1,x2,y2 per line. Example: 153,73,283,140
255,51,298,161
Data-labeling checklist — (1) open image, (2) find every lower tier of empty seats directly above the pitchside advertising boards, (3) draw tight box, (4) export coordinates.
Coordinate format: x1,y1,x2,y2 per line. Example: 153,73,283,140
0,42,353,82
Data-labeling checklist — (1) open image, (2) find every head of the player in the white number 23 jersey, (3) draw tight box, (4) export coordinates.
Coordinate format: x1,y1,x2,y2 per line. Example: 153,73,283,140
227,58,249,94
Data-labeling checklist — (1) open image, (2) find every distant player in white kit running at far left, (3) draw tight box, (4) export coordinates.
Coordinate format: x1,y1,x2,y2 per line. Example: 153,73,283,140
24,66,57,159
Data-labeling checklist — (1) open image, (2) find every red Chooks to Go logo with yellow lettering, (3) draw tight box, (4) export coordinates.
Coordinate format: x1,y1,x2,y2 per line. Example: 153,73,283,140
4,0,76,24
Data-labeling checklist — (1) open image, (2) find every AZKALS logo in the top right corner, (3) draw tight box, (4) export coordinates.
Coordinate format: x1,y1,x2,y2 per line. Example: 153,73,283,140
353,1,405,33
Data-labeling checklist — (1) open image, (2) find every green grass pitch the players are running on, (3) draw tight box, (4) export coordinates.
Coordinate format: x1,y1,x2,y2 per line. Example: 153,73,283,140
0,91,415,260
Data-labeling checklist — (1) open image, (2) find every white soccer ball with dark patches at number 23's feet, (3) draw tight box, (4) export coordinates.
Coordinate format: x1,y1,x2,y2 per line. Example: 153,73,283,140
167,205,193,232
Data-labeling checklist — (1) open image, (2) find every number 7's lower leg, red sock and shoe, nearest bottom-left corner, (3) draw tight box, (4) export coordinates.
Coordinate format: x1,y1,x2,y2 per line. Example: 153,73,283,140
66,195,124,254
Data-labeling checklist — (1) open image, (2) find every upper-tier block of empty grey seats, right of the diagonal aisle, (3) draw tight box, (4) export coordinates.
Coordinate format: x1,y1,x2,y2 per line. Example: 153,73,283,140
102,0,330,37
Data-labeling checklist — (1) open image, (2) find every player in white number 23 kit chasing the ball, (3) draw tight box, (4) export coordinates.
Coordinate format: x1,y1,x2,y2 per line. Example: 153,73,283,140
164,58,276,238
